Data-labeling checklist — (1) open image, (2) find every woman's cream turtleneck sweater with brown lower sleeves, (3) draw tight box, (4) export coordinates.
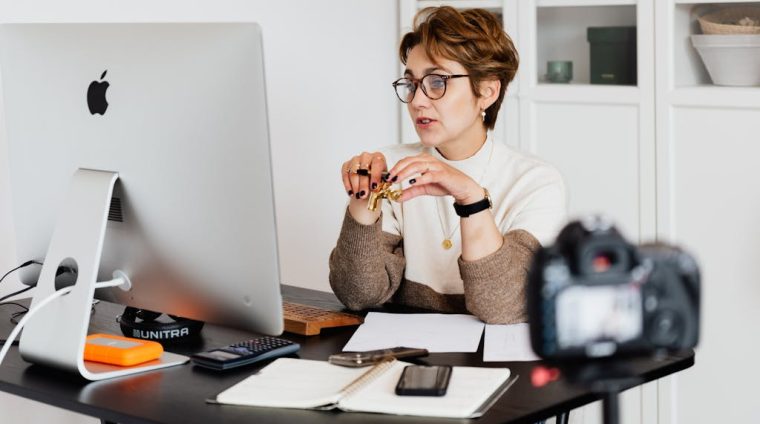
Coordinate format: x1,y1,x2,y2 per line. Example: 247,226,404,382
330,134,566,323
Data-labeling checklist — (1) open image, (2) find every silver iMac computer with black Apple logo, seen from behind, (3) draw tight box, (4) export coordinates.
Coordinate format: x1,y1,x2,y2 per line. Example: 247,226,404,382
0,23,283,380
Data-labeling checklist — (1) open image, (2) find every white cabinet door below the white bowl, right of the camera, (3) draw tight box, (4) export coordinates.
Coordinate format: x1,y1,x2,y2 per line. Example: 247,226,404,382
660,106,760,424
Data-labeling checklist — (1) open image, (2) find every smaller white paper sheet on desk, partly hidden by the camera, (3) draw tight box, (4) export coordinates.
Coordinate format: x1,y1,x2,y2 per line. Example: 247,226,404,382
483,324,540,362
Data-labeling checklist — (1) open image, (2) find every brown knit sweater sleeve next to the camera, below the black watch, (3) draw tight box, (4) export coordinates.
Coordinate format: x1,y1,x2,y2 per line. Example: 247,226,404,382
459,230,541,324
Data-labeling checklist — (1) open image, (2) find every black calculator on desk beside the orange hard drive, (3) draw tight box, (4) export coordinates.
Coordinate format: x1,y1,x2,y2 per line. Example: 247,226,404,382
190,336,301,370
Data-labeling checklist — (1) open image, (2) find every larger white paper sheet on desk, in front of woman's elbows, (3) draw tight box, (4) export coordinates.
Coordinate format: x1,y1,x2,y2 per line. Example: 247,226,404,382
343,312,484,352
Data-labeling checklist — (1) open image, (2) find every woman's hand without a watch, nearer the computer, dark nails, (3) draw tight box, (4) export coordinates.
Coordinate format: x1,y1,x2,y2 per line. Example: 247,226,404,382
341,152,388,225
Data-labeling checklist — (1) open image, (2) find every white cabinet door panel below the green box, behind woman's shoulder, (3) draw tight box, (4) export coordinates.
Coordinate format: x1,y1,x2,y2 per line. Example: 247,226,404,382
530,102,641,241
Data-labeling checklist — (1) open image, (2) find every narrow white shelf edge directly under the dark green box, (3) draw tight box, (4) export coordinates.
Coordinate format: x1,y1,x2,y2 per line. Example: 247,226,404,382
527,84,641,105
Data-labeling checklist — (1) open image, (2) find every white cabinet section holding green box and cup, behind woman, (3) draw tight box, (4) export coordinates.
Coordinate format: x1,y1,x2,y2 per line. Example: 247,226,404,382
518,0,655,240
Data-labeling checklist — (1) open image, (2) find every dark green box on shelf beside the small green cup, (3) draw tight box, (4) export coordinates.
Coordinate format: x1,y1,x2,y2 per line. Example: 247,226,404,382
588,27,636,85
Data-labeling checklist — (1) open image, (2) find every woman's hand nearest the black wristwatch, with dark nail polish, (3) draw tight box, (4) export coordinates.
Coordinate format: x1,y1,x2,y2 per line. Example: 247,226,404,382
388,153,483,205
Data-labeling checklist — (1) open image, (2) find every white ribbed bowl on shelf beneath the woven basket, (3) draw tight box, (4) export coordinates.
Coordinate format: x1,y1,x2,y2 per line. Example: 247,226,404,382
691,34,760,87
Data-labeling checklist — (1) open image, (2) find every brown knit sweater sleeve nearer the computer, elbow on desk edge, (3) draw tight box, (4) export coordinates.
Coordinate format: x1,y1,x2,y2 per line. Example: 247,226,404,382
330,208,406,310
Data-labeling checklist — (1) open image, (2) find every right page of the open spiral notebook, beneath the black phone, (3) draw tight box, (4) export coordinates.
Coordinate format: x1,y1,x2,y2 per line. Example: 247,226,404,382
339,361,510,418
